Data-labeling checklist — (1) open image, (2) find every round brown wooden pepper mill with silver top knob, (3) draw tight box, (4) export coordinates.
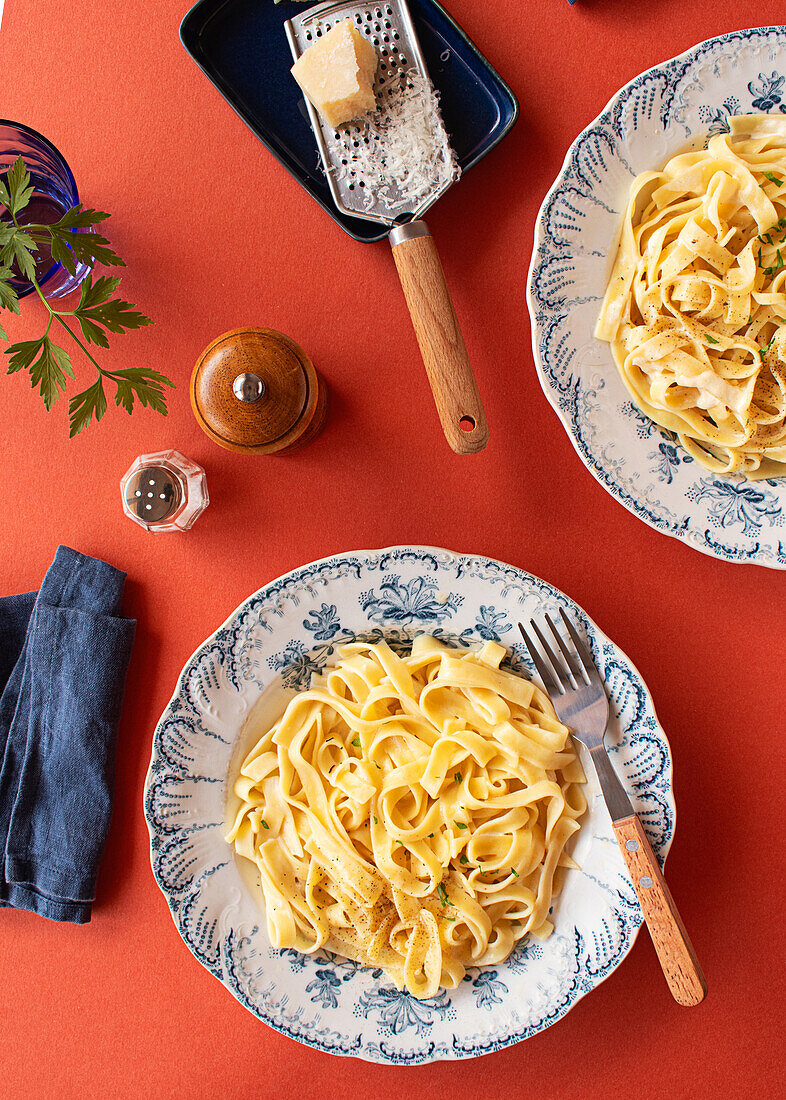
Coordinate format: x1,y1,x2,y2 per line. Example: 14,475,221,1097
190,328,326,454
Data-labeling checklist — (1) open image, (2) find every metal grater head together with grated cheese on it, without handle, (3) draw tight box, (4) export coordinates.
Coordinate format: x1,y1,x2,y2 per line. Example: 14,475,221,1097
286,0,461,226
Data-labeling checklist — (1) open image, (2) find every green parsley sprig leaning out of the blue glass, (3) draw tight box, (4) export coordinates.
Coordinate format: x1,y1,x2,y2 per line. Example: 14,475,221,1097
0,156,174,437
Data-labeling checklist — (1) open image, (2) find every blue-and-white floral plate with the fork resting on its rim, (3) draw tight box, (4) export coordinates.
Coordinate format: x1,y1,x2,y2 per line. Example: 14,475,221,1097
145,547,675,1065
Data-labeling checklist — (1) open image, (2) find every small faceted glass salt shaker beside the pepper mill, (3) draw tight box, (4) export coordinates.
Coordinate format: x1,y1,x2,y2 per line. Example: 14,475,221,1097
120,451,210,534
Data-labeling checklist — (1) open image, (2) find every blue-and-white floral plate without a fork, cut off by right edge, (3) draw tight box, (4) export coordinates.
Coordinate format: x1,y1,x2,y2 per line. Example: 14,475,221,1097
528,26,786,569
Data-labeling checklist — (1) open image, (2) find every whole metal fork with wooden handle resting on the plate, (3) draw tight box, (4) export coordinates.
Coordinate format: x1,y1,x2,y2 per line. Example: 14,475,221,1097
519,608,707,1004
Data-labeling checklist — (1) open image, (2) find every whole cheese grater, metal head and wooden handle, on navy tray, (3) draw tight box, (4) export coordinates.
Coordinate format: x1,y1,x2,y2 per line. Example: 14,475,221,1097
285,0,488,454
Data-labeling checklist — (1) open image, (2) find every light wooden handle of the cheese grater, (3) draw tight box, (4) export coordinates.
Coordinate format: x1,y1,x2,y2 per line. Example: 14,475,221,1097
390,221,488,454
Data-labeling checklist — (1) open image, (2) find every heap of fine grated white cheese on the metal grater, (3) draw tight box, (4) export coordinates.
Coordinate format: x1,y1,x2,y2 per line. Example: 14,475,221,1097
335,70,461,212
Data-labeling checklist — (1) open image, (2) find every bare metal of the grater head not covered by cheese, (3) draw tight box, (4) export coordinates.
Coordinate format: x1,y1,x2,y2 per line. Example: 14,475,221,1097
284,0,454,226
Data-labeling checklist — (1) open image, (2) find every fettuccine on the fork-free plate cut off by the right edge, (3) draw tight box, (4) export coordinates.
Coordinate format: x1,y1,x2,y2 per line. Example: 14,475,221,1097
595,114,786,479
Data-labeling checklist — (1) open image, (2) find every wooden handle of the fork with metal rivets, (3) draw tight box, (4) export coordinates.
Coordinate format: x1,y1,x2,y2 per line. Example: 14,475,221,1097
613,814,707,1004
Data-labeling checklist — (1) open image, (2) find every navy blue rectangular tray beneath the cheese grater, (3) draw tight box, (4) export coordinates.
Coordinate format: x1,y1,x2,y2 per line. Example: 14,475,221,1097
180,0,519,241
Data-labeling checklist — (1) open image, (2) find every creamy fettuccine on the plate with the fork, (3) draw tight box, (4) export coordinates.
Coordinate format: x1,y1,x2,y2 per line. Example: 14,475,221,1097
228,635,586,998
